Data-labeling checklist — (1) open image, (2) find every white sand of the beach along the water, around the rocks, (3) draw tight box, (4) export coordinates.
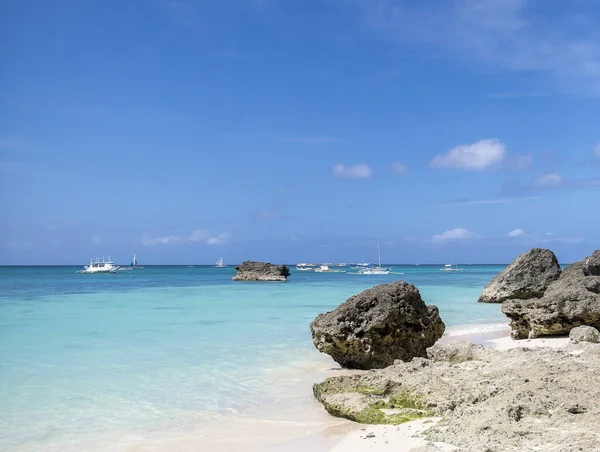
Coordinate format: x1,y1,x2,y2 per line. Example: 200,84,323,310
21,324,569,452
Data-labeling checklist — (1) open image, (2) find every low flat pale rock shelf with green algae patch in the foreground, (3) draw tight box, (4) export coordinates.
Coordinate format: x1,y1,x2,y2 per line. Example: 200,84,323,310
313,342,600,452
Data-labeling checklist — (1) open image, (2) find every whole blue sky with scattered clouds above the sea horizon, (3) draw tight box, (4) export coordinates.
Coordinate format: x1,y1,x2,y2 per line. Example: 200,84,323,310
0,0,600,264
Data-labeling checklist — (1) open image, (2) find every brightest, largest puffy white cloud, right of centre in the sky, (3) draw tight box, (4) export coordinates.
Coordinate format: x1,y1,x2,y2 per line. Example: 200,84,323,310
431,139,506,171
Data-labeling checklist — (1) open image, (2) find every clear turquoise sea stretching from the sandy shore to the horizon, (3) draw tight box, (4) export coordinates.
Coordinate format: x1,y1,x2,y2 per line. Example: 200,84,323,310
0,265,506,451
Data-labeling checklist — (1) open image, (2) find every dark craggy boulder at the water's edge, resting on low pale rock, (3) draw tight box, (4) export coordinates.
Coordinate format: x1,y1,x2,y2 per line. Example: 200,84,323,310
310,281,445,369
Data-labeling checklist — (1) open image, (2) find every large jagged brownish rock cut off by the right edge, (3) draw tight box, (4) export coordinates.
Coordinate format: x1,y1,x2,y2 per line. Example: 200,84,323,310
502,250,600,339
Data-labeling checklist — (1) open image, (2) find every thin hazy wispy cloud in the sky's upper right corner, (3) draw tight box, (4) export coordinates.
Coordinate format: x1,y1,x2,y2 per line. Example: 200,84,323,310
362,0,600,95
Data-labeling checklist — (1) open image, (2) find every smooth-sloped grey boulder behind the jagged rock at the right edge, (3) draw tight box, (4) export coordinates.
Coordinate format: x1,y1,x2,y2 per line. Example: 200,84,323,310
479,248,561,303
